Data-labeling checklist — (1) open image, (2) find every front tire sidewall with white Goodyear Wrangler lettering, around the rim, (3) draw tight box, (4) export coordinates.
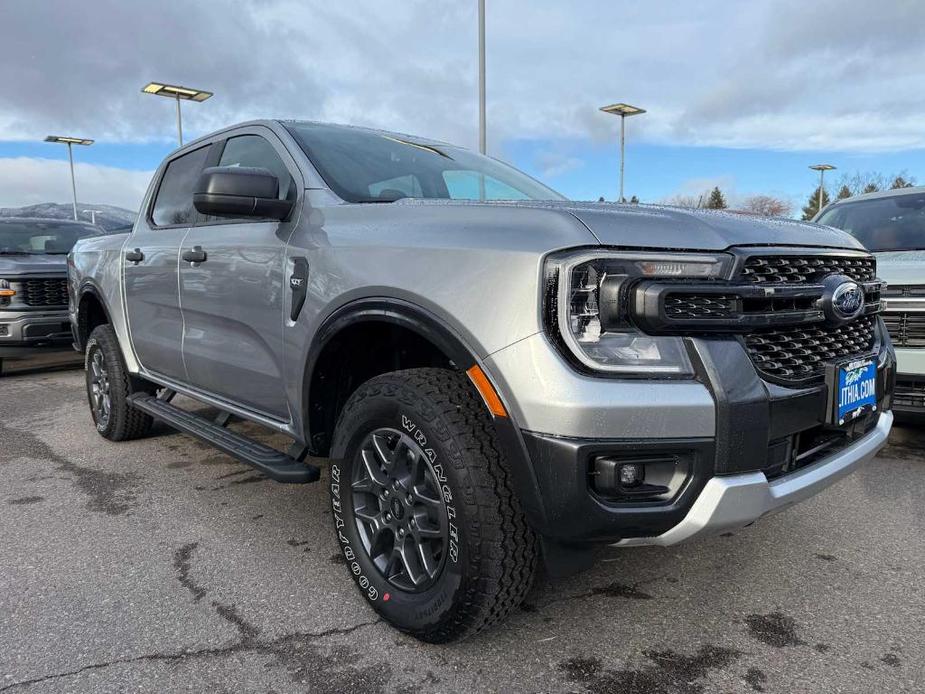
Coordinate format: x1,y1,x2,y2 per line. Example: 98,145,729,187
330,386,473,631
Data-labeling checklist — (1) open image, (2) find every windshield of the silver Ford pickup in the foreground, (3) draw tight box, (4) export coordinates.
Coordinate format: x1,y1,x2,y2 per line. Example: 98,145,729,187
286,123,565,202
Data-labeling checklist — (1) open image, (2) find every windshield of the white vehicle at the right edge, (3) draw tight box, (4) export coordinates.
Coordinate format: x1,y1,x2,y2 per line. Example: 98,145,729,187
816,192,925,251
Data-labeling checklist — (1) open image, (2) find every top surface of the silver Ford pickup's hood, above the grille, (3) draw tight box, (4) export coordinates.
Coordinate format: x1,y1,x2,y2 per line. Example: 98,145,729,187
393,198,863,251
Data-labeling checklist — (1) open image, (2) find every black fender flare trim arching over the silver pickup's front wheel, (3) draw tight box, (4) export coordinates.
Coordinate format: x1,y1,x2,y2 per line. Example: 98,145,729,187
302,298,546,528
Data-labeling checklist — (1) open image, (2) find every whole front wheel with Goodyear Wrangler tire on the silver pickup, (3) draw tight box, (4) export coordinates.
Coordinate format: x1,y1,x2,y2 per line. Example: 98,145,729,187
331,368,537,643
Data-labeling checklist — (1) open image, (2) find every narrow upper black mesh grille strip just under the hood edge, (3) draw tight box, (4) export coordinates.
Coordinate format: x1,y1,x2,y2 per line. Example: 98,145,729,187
741,255,877,284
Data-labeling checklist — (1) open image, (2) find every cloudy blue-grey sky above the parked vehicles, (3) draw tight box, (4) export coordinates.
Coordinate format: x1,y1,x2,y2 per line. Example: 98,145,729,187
0,0,925,213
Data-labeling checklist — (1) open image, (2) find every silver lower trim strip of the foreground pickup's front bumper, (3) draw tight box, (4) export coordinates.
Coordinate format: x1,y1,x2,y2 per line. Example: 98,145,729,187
615,412,893,547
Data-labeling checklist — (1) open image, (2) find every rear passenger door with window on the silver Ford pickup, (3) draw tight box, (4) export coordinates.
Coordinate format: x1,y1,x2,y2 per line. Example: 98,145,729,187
122,145,210,381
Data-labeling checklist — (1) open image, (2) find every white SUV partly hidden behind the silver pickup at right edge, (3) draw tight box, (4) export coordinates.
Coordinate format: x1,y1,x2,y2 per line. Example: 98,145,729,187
813,186,925,414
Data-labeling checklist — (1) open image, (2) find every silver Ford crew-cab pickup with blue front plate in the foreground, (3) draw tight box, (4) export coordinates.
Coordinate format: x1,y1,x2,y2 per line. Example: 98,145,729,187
69,121,895,642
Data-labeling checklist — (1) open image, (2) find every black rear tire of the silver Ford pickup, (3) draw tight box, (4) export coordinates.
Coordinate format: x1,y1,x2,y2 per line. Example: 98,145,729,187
84,324,154,441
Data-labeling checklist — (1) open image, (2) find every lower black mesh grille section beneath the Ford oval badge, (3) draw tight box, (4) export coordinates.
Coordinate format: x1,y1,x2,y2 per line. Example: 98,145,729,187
743,316,876,381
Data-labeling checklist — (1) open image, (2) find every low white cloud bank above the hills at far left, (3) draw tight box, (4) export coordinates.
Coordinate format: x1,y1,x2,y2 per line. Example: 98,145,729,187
0,157,154,211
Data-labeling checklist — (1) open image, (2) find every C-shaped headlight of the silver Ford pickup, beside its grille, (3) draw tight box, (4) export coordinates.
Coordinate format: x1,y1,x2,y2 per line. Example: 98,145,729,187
546,252,731,378
